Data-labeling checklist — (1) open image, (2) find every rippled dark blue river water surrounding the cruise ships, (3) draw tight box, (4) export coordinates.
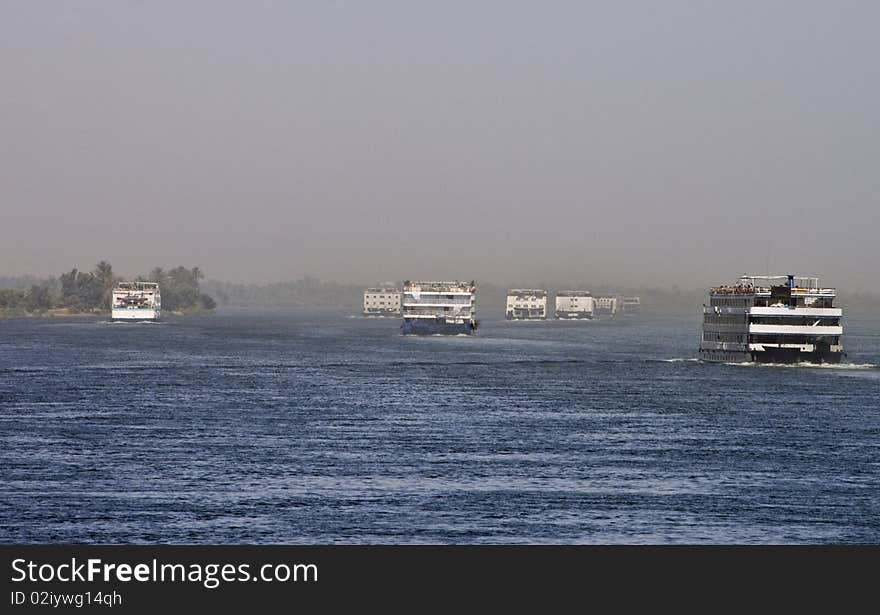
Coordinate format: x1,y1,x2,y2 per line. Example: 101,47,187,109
0,310,880,544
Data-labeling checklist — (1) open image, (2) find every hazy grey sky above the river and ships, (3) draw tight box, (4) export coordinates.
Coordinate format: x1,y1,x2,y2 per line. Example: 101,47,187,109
0,0,880,289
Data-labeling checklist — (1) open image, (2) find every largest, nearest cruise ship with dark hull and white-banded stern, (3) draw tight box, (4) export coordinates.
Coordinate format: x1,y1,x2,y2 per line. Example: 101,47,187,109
700,275,843,363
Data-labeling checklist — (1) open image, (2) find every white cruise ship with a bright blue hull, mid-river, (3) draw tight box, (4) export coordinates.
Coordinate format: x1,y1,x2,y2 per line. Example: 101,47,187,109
401,281,477,335
